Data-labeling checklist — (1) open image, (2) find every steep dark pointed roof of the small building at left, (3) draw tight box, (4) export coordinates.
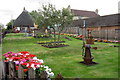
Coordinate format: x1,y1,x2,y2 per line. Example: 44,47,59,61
13,8,34,27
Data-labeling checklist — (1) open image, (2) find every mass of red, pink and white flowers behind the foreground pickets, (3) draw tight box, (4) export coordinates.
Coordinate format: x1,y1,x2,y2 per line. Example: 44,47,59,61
3,51,54,77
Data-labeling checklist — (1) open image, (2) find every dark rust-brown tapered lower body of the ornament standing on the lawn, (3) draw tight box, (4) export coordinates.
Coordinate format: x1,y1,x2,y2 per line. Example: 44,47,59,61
80,44,97,65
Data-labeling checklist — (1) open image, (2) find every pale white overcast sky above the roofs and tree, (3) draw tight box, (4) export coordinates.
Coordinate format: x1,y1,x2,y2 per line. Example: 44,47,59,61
0,0,120,25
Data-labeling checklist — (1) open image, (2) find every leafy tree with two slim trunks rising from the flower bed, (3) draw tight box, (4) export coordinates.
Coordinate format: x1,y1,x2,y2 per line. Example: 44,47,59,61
30,4,73,41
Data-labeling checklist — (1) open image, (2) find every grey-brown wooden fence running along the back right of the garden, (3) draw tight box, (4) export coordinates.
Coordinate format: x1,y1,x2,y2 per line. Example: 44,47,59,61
63,27,120,40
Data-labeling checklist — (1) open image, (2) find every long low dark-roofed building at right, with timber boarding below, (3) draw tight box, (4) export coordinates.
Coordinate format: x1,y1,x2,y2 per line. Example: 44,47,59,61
67,13,120,40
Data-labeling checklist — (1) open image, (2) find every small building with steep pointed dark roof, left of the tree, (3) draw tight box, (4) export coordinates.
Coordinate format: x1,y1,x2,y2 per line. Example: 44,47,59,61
13,8,34,32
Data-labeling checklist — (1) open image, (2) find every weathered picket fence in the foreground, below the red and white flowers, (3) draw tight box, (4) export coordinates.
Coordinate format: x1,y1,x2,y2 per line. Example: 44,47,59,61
0,61,63,80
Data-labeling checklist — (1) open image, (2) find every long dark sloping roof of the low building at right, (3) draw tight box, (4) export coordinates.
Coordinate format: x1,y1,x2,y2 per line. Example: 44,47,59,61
73,14,120,27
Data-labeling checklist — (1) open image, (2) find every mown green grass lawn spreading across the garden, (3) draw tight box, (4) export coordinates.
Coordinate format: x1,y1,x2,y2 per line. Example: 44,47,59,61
2,33,118,78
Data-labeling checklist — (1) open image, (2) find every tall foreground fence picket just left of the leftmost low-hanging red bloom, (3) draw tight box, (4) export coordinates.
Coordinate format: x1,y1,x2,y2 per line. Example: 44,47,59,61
8,61,16,79
